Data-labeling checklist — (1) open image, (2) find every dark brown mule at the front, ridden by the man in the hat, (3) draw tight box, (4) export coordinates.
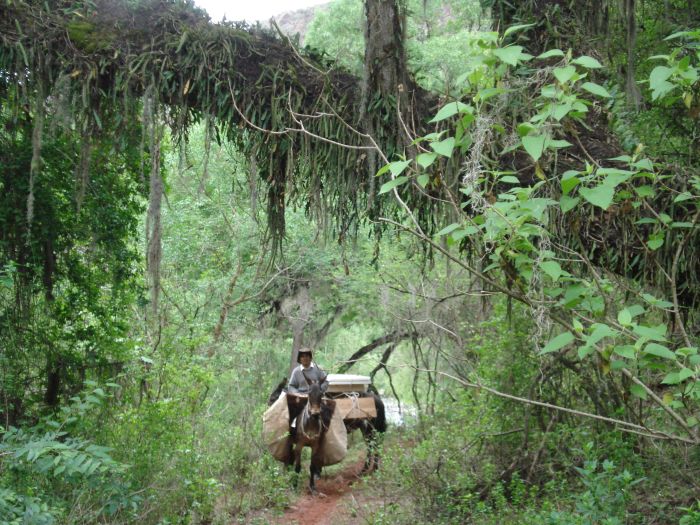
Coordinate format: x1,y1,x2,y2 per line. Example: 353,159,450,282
288,376,335,493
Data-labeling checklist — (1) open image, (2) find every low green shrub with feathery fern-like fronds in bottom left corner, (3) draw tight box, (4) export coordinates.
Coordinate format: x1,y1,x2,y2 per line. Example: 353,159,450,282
0,388,140,525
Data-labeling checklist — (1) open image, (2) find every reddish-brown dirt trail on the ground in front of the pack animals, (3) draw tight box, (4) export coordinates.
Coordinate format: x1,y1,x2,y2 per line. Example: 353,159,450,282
272,461,363,525
